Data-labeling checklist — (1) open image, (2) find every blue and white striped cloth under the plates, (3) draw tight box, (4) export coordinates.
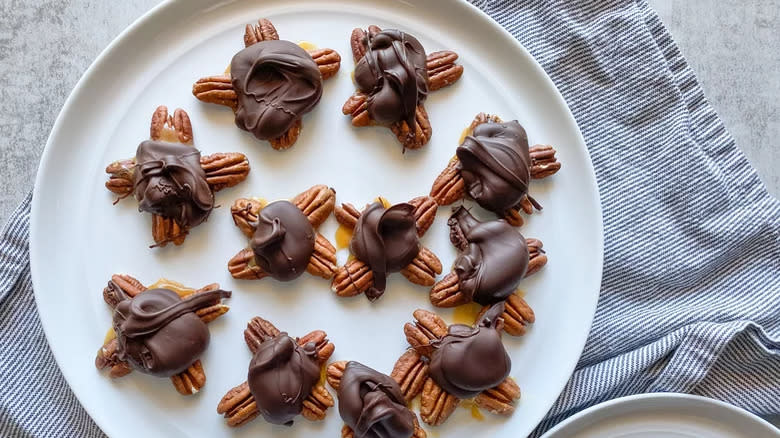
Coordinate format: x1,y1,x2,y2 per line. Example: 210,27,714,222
0,0,780,437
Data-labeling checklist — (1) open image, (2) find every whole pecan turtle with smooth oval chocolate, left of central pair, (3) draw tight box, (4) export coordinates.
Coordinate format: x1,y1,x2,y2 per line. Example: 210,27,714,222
228,185,336,281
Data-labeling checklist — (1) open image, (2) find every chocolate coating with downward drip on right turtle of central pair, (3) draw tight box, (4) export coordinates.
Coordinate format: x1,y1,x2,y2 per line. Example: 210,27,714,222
349,202,420,301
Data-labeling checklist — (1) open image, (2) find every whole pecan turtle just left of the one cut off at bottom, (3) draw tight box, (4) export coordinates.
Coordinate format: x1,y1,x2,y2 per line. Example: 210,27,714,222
217,317,335,427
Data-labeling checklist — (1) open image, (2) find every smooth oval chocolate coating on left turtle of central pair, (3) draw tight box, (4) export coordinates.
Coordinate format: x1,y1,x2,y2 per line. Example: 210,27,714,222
251,201,314,281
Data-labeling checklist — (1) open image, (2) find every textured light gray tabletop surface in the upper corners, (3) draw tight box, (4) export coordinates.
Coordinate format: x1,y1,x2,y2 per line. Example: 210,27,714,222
0,0,780,223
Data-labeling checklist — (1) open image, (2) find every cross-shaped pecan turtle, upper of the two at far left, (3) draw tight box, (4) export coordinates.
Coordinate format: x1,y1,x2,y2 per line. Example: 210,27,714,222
106,106,249,247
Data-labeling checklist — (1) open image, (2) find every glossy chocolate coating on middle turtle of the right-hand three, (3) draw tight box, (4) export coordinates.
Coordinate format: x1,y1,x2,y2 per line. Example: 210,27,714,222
447,207,529,305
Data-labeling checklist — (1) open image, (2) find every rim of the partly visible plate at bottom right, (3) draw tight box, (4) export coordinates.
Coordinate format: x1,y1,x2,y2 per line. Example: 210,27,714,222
541,392,780,438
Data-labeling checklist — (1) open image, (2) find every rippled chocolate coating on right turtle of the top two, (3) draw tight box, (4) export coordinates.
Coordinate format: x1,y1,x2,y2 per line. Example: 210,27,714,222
355,29,428,128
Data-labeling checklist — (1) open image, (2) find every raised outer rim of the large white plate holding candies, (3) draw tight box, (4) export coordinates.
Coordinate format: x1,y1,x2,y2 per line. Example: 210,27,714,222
29,0,604,436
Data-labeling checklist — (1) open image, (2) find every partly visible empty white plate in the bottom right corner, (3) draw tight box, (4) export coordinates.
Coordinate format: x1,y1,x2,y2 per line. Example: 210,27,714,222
542,393,780,438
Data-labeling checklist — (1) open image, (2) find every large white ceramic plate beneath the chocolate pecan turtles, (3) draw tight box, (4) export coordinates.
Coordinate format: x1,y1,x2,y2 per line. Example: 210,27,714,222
30,0,602,437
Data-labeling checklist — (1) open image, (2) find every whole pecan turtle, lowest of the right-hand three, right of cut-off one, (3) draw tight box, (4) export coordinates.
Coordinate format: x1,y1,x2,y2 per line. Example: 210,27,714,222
390,303,520,426
